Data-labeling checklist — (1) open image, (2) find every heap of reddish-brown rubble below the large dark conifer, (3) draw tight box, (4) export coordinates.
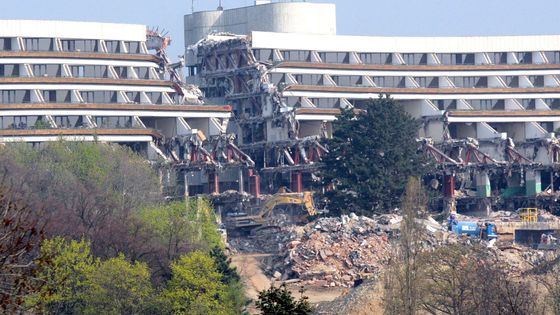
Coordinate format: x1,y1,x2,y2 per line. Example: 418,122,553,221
271,214,393,287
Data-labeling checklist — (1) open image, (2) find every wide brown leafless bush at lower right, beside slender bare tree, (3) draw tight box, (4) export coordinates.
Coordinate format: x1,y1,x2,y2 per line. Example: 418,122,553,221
422,244,544,315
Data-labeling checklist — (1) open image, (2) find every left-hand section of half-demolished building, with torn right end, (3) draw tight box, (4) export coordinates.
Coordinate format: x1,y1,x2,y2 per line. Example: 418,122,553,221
0,20,250,192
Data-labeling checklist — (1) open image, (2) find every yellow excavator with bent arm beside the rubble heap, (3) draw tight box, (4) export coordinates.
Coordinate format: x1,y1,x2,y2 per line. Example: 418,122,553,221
225,188,317,234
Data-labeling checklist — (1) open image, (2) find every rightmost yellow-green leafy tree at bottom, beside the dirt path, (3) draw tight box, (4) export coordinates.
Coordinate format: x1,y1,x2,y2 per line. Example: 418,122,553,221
161,251,233,315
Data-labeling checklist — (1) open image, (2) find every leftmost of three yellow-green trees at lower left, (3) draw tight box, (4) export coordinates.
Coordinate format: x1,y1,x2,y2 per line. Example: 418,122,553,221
28,237,99,314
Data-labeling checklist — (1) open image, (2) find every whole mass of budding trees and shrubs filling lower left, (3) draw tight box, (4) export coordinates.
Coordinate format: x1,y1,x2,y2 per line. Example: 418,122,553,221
0,141,247,314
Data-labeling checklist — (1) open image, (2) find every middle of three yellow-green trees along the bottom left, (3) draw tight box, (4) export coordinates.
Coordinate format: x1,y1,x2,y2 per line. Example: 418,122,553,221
84,254,155,315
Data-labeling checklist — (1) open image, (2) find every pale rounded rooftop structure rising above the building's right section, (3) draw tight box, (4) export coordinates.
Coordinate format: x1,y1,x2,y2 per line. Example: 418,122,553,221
184,2,336,47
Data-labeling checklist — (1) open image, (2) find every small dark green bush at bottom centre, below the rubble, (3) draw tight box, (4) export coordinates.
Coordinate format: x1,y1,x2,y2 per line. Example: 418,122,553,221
256,284,312,315
